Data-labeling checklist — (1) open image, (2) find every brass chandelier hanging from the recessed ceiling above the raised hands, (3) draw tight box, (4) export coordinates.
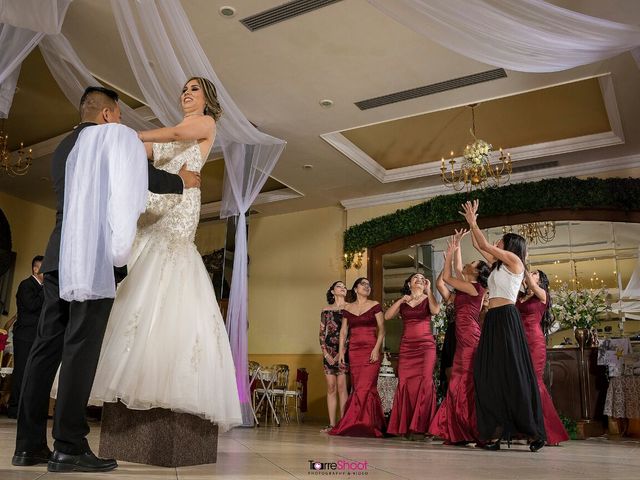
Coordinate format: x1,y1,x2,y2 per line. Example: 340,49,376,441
440,103,512,191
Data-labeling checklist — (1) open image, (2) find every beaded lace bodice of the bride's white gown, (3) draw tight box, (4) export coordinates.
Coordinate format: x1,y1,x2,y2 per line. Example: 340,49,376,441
138,140,204,242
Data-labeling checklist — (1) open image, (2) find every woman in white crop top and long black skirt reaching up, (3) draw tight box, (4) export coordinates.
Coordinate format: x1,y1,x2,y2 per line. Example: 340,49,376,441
460,200,546,452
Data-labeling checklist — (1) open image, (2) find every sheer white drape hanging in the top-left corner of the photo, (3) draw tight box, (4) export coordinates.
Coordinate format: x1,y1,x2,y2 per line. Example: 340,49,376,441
0,0,72,118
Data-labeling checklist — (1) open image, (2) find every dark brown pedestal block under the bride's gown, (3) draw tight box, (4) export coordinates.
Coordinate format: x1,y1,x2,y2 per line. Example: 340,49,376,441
99,402,218,467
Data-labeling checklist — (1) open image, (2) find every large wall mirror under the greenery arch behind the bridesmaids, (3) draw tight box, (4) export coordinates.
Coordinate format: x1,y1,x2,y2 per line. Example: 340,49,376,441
380,220,640,353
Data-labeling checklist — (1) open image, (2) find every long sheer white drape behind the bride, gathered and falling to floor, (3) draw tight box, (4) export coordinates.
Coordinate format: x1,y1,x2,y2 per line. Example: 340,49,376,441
111,0,285,424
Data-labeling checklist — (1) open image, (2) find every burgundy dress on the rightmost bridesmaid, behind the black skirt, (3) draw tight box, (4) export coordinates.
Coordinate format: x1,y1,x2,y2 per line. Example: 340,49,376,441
516,295,569,445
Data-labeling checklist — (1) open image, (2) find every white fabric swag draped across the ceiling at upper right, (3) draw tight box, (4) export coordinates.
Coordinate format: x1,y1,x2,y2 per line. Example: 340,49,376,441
369,0,640,72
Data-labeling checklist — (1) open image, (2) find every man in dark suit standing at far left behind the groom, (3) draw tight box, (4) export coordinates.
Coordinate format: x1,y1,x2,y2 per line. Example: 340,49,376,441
7,255,44,418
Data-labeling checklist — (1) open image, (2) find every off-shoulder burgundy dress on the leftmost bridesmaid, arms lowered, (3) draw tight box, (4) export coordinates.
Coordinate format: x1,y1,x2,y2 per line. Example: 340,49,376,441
329,304,385,437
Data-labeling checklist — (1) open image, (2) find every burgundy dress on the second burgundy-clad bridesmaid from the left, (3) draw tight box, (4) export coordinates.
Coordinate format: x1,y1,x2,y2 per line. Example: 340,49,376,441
387,298,436,435
